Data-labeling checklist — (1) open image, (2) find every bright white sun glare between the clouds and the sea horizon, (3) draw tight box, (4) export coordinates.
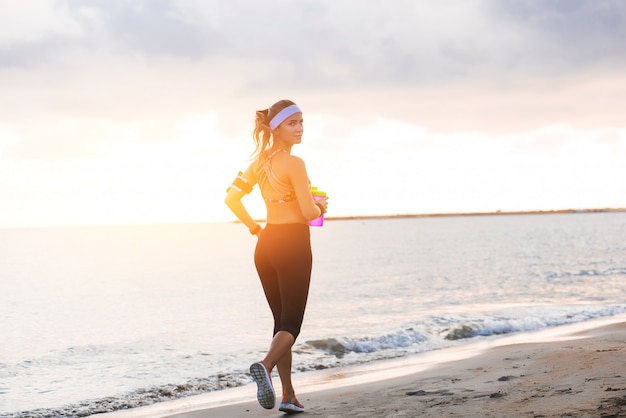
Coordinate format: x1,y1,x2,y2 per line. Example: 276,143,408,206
0,113,626,227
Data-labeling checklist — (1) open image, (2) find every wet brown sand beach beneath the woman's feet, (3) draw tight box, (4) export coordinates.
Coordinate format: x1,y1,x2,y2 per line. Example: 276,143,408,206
106,316,626,418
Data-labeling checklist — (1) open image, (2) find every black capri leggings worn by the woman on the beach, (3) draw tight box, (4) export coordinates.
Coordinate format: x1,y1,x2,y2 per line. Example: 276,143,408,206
254,224,313,339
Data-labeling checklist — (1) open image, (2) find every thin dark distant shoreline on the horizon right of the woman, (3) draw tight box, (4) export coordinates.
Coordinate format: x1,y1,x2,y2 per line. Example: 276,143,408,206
324,208,626,221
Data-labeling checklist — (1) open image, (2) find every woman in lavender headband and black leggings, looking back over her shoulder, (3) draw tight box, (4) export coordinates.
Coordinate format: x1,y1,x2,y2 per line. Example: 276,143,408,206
225,100,328,413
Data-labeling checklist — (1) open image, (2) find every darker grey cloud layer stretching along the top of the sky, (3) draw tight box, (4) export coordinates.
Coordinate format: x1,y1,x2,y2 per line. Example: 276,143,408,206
3,0,626,79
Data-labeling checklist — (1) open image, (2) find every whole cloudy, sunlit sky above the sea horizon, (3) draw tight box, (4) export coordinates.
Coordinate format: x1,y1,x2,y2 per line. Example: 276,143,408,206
0,0,626,228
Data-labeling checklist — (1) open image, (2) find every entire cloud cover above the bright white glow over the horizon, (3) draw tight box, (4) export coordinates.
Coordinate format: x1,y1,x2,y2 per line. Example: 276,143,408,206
0,0,626,155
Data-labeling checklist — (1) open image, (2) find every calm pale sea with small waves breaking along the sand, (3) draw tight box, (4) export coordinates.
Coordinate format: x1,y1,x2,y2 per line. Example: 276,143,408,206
0,212,626,418
